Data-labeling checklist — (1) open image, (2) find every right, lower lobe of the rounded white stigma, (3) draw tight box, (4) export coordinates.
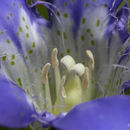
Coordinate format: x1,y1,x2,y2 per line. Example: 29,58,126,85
70,63,85,76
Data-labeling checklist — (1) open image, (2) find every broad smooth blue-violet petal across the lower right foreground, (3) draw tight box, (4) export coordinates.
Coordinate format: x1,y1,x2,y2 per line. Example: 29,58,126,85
53,96,130,130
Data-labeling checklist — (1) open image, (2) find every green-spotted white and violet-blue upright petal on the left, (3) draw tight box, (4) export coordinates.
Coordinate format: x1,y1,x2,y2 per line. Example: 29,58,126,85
0,0,47,110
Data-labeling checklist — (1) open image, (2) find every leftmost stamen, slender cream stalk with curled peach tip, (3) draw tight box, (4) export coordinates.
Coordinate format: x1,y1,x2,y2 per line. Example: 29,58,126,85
42,63,52,111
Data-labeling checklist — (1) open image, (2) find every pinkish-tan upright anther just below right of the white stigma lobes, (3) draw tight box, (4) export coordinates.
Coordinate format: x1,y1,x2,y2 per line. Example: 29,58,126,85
83,67,89,90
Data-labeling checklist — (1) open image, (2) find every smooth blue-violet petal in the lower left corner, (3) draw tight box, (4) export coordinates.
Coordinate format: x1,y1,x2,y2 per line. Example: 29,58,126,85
0,75,35,128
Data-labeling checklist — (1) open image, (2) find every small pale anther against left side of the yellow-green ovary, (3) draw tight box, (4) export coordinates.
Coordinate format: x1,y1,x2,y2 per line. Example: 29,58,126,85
60,76,66,98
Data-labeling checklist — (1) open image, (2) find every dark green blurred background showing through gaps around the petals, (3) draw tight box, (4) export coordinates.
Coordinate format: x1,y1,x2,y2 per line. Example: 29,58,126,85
0,0,130,130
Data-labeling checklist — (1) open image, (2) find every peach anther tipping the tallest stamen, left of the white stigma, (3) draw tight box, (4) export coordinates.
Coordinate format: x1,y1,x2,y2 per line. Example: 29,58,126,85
51,48,59,68
